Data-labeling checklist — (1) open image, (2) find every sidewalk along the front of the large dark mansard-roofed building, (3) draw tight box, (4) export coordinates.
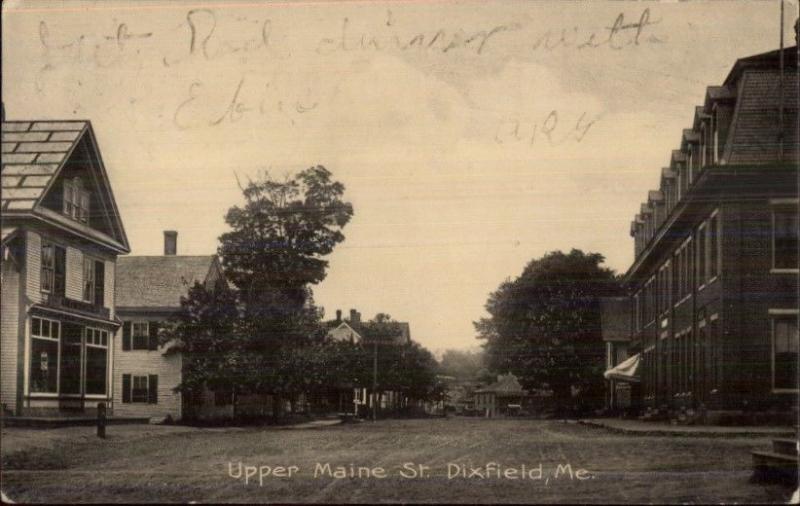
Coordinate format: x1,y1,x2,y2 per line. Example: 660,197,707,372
578,418,795,438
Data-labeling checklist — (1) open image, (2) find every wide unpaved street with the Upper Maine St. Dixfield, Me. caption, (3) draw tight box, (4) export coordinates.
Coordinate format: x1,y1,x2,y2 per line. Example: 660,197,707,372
2,418,790,503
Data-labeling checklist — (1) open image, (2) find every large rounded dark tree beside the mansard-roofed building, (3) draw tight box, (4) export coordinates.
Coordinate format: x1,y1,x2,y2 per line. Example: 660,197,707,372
475,249,617,416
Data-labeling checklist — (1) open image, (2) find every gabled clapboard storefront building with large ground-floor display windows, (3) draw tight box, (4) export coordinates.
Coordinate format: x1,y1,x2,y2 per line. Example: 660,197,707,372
0,121,129,416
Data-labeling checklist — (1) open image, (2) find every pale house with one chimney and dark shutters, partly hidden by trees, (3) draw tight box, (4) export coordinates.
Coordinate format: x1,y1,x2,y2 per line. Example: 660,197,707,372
114,231,232,420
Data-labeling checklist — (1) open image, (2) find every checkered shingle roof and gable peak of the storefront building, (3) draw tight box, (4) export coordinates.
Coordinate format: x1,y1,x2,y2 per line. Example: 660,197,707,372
0,121,130,253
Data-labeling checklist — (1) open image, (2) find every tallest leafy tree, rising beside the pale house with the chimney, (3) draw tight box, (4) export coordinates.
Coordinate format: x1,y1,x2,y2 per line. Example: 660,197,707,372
219,165,353,412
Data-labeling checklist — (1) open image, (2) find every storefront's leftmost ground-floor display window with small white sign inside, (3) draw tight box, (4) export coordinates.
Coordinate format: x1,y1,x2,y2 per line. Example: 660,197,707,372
29,318,61,394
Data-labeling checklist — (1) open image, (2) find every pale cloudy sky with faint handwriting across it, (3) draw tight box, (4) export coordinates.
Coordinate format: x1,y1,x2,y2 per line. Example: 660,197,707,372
2,0,797,351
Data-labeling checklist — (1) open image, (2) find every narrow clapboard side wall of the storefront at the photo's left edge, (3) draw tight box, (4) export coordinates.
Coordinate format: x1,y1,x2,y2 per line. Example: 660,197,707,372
0,260,20,411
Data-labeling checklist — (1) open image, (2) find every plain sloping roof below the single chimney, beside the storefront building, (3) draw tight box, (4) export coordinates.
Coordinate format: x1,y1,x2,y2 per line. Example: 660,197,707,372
115,255,221,309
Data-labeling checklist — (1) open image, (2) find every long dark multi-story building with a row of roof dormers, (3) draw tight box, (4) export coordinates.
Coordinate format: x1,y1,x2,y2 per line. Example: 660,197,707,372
624,37,800,419
